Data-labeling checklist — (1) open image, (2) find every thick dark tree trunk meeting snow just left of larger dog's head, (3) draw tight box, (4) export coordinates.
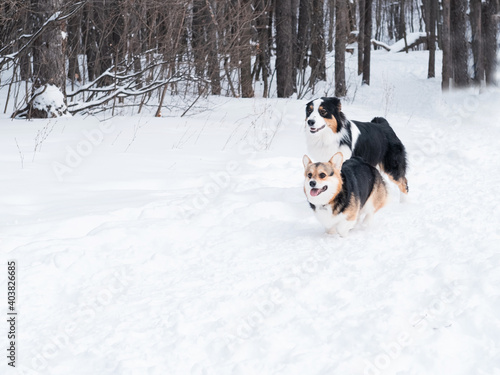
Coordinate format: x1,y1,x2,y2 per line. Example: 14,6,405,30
275,0,293,98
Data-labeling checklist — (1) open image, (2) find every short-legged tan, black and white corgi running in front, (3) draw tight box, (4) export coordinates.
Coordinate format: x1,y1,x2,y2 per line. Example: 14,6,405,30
302,152,387,237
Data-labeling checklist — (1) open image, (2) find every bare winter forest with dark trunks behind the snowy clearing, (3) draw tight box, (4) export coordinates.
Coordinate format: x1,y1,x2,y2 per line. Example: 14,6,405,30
0,0,500,118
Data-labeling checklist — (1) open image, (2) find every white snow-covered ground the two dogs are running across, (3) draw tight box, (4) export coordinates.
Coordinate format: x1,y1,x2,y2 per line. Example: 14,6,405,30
0,51,500,375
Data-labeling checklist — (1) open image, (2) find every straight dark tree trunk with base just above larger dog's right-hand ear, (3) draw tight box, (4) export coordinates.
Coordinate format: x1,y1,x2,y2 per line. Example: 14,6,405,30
335,0,349,97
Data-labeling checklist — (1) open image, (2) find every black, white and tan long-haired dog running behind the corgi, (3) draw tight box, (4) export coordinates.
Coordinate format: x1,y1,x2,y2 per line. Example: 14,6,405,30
306,98,408,194
